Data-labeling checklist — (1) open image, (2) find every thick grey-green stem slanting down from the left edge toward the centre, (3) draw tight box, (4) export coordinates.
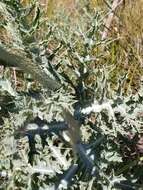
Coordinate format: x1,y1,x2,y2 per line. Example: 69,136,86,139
0,47,61,91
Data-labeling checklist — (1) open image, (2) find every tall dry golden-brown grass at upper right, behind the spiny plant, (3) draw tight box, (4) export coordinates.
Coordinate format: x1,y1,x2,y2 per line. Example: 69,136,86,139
101,0,143,94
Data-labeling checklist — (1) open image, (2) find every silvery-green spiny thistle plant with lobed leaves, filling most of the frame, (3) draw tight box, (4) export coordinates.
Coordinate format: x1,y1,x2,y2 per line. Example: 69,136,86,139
0,0,143,190
